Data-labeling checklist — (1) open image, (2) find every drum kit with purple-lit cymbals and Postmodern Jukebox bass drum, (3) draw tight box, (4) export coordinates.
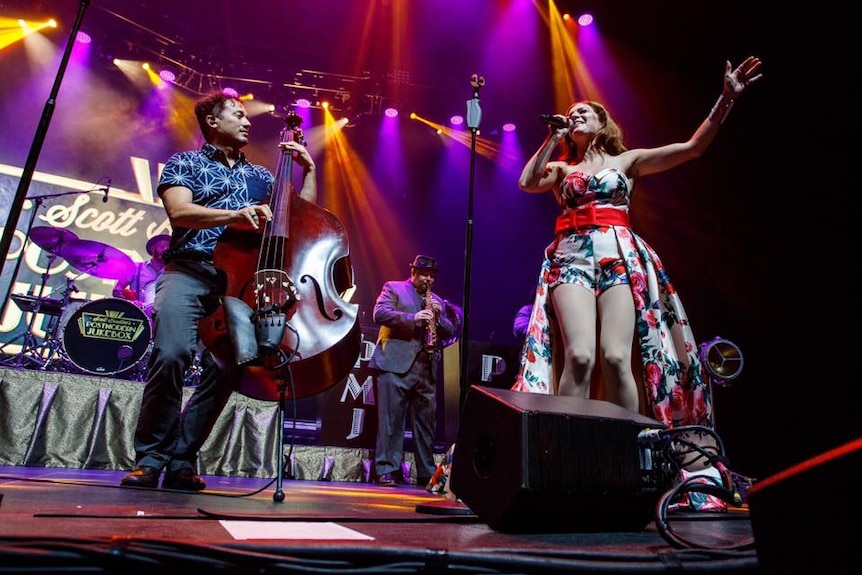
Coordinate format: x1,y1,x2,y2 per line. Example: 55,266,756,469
2,227,152,375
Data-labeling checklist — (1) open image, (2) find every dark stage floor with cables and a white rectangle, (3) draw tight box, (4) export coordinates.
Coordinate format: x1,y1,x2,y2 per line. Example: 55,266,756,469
0,467,761,574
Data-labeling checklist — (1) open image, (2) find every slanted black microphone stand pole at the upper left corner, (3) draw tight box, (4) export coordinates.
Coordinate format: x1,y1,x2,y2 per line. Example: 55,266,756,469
0,0,90,299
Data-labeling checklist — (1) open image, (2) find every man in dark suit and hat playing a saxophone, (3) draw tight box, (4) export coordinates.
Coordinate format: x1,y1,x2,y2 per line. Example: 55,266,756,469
369,255,455,487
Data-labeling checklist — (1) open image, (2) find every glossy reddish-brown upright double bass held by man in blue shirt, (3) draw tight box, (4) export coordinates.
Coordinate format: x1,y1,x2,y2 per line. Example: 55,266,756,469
199,112,362,400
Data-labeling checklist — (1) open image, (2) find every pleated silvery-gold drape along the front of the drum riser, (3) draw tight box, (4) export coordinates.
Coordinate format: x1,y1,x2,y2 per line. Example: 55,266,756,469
0,368,372,481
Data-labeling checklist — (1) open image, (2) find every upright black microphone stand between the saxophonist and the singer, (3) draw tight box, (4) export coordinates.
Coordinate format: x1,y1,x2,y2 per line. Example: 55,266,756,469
458,74,485,411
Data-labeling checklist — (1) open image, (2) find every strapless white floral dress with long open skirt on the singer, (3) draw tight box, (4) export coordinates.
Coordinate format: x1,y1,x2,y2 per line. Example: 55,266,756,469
512,168,713,428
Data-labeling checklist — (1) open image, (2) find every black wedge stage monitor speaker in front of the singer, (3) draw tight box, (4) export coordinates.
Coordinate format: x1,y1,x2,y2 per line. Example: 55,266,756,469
450,385,672,533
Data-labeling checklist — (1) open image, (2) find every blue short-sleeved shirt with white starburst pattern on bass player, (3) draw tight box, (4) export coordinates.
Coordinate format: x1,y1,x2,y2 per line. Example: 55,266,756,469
157,143,275,260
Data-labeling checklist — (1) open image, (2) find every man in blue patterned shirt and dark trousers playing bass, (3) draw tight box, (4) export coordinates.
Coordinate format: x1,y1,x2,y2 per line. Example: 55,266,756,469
120,92,317,491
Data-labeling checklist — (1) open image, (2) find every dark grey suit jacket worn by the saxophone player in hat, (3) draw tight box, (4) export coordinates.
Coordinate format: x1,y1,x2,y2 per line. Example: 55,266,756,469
368,278,455,378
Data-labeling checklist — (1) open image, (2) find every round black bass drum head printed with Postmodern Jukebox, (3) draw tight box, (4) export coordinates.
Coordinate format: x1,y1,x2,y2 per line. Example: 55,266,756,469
62,298,152,375
